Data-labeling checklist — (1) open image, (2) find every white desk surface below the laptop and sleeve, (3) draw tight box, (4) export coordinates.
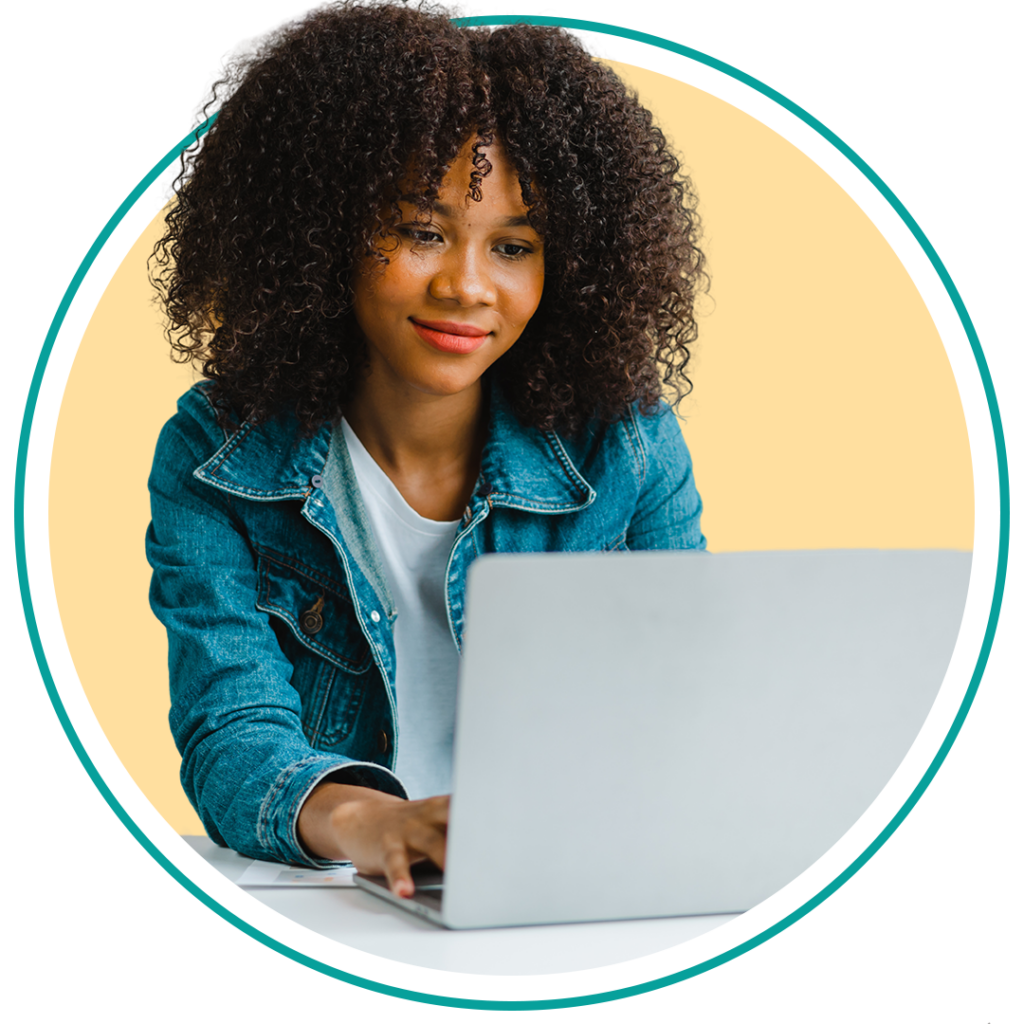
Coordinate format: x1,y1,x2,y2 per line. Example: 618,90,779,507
181,836,736,977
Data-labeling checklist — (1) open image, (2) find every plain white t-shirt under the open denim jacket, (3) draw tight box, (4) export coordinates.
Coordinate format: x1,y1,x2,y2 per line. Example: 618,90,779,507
341,420,459,800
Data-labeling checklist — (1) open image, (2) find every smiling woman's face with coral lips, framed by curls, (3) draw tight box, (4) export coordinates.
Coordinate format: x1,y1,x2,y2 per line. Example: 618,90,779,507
353,142,544,396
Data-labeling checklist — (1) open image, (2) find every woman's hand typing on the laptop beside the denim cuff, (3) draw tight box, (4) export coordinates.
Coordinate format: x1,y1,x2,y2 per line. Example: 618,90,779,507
298,782,449,896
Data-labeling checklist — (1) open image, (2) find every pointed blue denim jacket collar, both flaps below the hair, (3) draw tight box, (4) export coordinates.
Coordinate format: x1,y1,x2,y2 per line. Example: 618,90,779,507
195,374,596,513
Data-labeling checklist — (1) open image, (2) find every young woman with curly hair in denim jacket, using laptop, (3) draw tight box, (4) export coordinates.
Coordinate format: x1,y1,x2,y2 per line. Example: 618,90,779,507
146,3,705,895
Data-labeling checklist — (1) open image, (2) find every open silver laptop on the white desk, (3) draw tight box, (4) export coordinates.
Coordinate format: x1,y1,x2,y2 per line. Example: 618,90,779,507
355,550,973,928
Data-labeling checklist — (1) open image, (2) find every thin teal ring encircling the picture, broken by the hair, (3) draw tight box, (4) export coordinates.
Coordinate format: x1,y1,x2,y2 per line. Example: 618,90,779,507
14,15,1010,1010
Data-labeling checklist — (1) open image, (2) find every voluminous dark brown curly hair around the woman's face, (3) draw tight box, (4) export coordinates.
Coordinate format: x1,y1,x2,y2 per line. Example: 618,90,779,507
153,3,707,435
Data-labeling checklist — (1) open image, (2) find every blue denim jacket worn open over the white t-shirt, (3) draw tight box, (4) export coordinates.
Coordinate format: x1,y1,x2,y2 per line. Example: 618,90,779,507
146,382,706,865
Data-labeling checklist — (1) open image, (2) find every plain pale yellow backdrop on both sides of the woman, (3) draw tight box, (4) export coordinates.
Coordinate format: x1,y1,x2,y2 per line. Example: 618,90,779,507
49,58,974,835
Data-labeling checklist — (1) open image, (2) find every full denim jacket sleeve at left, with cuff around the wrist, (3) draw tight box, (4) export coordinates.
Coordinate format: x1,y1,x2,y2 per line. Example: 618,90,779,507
145,395,406,866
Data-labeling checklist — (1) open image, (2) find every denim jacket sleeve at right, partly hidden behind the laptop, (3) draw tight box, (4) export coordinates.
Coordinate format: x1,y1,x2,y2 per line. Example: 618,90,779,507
626,401,708,551
